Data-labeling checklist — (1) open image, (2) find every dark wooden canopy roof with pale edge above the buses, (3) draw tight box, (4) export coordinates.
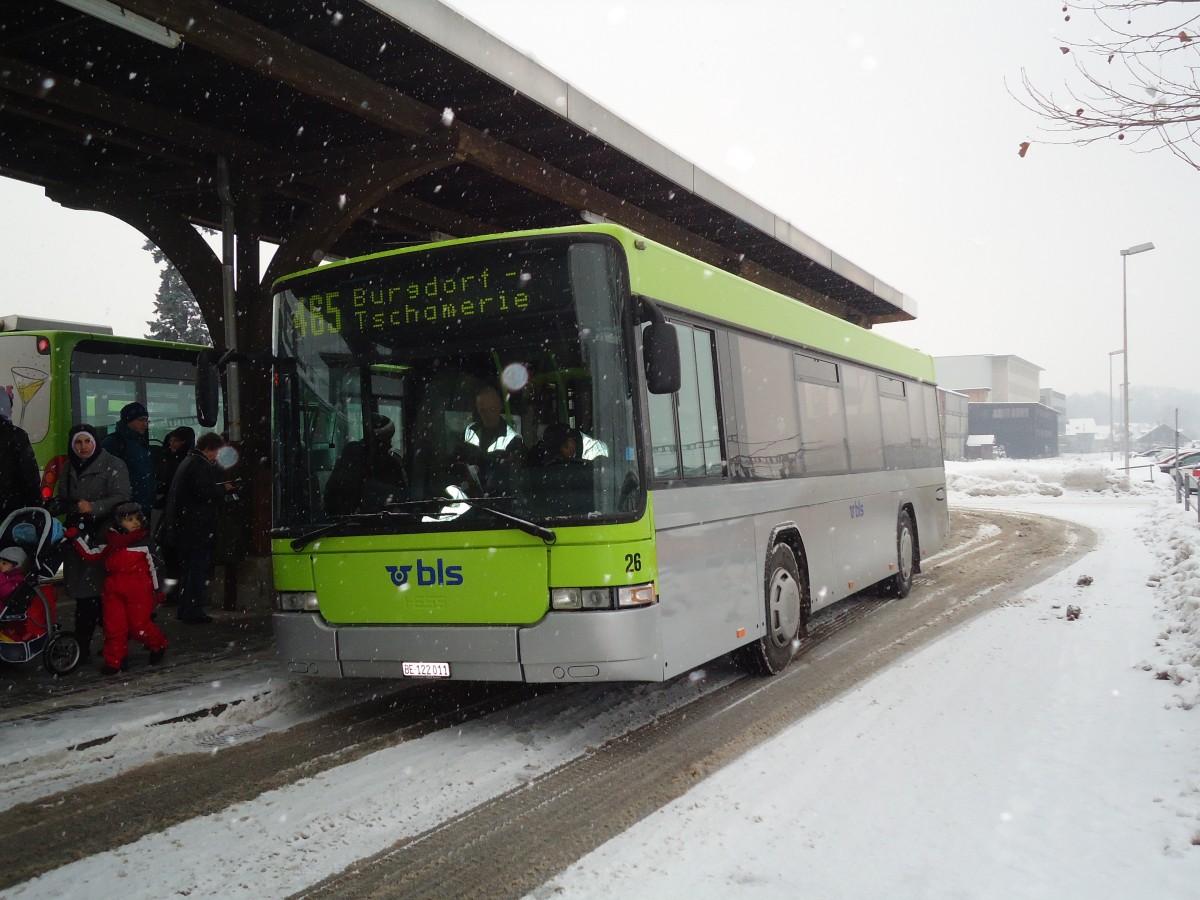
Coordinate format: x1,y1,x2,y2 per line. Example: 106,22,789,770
0,0,916,325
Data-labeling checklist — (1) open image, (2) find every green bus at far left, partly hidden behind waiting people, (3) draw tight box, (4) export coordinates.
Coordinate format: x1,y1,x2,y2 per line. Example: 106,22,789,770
0,316,213,496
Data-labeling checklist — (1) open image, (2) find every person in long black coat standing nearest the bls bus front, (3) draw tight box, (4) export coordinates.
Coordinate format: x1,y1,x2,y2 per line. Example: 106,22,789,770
162,431,233,624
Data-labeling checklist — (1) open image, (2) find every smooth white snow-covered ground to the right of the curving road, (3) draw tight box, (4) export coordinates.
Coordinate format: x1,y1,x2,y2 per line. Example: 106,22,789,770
536,457,1200,900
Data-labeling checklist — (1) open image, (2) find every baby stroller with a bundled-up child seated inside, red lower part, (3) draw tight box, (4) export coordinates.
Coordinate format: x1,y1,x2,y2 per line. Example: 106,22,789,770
0,506,80,674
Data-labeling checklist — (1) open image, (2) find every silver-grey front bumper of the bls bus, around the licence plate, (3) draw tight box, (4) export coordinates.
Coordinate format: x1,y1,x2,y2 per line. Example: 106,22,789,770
272,604,666,683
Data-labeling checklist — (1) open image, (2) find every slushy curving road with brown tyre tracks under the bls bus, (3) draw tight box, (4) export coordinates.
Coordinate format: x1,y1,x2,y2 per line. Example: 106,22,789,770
0,514,1088,896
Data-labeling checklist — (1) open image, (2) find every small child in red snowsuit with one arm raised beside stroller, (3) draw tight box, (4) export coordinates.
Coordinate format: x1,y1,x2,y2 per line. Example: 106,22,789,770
66,502,167,674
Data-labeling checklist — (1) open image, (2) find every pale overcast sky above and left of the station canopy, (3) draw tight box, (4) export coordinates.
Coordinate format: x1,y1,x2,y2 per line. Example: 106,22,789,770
0,0,1200,394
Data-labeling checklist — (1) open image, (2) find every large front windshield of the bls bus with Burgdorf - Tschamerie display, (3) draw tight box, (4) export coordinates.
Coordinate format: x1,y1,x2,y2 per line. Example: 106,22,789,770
275,235,642,533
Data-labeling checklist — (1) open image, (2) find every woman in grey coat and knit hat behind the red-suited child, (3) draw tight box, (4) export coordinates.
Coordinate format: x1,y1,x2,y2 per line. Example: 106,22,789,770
50,425,130,658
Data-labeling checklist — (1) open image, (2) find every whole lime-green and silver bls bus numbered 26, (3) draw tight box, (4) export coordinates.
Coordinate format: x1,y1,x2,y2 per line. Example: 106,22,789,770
272,224,948,683
